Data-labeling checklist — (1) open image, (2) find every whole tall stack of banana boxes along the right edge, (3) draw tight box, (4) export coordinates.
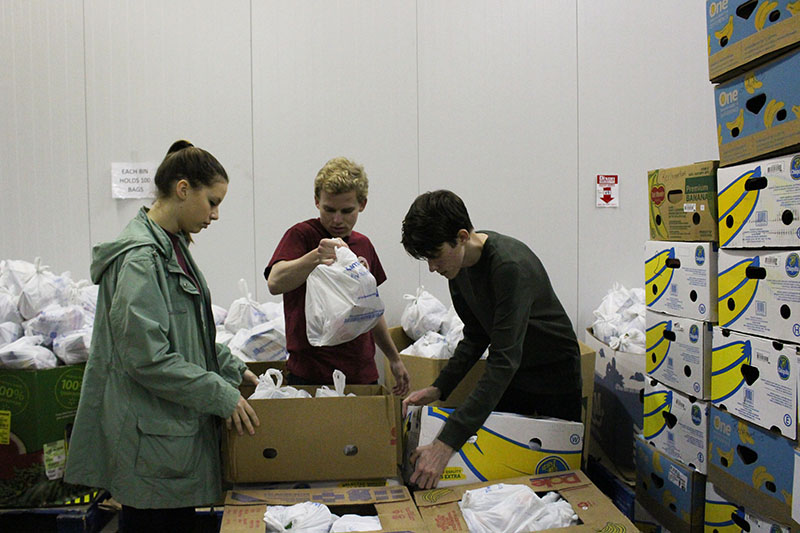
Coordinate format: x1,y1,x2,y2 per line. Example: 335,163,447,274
636,0,800,531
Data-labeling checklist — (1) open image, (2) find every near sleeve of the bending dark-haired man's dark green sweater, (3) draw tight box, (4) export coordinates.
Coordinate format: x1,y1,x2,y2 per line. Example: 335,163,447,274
438,263,533,450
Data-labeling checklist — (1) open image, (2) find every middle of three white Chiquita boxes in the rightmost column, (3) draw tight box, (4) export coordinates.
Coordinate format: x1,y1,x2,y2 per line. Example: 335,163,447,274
717,249,800,342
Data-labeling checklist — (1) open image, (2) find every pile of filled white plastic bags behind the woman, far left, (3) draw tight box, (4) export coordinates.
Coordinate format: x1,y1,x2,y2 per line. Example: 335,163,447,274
0,258,97,369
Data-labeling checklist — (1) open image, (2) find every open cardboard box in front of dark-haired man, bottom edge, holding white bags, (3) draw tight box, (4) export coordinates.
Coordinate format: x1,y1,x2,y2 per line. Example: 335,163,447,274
414,470,637,533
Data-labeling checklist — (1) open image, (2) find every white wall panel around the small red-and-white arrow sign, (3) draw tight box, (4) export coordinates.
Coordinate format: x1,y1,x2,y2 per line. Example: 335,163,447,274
577,0,718,338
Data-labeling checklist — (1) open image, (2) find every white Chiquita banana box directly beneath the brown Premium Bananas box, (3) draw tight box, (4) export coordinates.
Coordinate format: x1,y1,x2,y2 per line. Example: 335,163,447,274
644,241,717,322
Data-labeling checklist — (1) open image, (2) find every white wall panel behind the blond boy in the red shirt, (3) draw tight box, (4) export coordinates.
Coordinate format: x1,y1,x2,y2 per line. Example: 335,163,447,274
253,0,418,325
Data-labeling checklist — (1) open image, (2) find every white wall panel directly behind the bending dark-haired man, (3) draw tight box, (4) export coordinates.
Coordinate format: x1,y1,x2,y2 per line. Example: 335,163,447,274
418,1,578,321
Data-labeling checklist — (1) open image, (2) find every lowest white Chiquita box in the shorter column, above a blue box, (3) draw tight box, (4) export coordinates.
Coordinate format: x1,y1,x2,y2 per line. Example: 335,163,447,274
642,379,710,474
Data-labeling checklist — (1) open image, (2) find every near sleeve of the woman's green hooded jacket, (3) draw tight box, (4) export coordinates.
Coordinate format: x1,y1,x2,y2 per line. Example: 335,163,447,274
109,251,239,418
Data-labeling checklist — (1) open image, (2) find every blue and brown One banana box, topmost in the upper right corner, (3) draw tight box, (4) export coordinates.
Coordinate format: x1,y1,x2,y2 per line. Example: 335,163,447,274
706,0,800,83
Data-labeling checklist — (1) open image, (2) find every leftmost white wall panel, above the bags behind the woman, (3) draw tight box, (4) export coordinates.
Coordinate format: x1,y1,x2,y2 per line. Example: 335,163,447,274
0,0,89,274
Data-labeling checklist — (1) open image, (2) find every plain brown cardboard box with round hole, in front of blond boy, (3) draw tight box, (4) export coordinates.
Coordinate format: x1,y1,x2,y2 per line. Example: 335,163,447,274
223,363,398,483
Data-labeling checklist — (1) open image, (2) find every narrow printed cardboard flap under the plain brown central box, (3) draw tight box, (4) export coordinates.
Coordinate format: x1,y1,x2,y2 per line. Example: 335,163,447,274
225,485,411,506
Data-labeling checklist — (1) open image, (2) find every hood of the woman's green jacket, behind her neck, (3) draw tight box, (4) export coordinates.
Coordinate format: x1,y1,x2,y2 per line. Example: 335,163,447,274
89,207,178,284
